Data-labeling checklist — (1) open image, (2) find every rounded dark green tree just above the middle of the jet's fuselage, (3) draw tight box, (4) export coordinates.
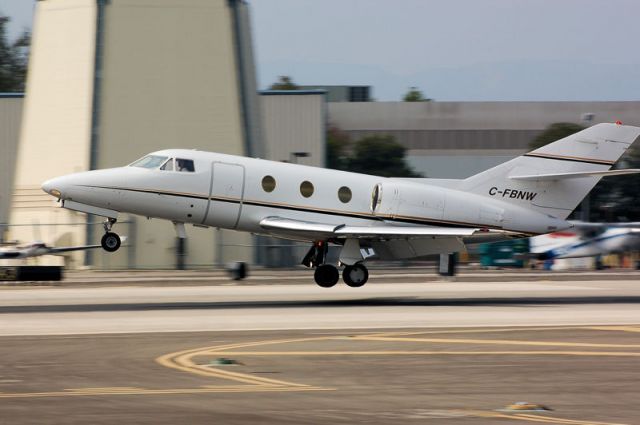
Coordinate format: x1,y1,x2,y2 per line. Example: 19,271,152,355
348,136,422,177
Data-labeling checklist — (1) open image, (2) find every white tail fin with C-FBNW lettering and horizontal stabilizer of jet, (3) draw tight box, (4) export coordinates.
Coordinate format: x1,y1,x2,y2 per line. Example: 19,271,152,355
458,124,640,219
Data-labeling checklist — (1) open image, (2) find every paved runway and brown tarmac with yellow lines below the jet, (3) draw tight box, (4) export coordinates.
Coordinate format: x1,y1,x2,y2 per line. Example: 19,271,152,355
0,275,640,425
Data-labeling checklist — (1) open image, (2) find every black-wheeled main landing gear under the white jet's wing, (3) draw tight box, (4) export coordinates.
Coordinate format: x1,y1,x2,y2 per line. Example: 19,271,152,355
302,241,369,288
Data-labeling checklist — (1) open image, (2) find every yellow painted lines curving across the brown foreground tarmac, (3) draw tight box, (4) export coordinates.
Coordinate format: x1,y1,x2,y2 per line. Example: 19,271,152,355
0,325,640,425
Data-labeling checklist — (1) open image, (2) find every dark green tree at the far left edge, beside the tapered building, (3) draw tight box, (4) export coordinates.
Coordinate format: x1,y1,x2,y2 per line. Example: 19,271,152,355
0,15,31,93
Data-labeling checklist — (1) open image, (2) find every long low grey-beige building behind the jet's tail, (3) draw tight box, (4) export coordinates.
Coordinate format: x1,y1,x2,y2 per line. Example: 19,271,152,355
329,102,640,178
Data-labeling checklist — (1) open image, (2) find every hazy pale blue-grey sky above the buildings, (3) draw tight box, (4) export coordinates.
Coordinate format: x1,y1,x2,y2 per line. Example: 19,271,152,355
0,0,640,101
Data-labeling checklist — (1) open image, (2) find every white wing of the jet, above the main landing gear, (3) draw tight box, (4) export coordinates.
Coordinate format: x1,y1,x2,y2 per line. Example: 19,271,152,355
260,217,516,240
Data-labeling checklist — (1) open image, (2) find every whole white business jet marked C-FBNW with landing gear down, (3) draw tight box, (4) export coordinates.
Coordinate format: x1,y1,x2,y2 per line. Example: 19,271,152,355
42,123,640,287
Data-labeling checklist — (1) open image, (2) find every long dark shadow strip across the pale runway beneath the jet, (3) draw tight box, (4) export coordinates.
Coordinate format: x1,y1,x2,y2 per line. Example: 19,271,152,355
0,296,640,314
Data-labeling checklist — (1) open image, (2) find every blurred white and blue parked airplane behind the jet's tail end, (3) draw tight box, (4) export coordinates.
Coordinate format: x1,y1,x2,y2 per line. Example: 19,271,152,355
530,221,640,267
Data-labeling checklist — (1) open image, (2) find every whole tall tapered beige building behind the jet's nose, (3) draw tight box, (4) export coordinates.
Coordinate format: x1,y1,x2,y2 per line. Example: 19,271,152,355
11,0,263,268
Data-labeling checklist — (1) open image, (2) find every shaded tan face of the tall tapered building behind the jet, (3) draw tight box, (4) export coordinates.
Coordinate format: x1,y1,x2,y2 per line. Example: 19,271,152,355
88,0,251,268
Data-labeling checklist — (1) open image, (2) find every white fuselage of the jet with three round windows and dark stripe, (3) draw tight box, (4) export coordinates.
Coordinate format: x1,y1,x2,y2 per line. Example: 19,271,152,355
43,149,570,240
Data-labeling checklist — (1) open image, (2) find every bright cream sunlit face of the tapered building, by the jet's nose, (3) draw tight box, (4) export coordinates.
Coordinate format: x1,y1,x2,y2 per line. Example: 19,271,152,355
10,0,96,263
